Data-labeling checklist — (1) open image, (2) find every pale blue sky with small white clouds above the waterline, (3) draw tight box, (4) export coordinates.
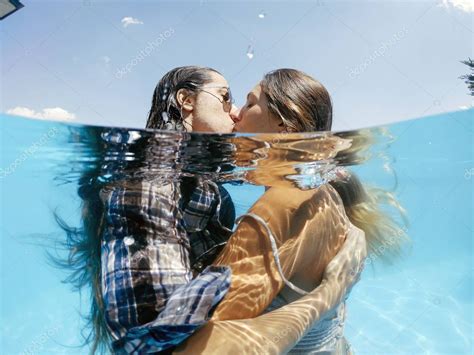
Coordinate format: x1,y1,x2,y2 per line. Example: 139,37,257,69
0,0,474,130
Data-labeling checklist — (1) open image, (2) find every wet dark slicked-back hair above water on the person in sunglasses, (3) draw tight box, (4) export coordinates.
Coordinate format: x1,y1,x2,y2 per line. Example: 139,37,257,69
146,66,222,131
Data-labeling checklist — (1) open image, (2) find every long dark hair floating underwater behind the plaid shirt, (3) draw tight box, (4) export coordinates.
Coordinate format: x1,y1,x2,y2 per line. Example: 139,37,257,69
48,126,112,355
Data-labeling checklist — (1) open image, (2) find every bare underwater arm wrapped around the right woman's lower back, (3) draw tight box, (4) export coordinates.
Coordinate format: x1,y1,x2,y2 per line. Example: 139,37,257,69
176,226,367,354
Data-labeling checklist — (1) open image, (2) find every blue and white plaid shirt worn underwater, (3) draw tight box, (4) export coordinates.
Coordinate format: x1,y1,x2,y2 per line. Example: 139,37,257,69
100,180,235,354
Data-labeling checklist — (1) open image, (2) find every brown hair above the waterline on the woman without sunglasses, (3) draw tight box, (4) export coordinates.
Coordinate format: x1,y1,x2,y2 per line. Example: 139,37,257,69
260,68,332,132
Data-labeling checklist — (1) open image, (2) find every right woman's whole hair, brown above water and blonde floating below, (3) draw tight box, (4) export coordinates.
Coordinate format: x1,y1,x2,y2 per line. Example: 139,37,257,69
260,68,408,261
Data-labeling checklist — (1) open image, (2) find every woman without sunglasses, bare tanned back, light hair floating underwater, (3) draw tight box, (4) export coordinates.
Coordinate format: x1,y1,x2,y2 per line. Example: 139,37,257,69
176,69,406,353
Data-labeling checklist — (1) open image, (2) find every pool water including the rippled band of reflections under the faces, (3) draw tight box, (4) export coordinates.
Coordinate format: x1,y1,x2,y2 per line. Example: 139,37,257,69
0,110,474,354
